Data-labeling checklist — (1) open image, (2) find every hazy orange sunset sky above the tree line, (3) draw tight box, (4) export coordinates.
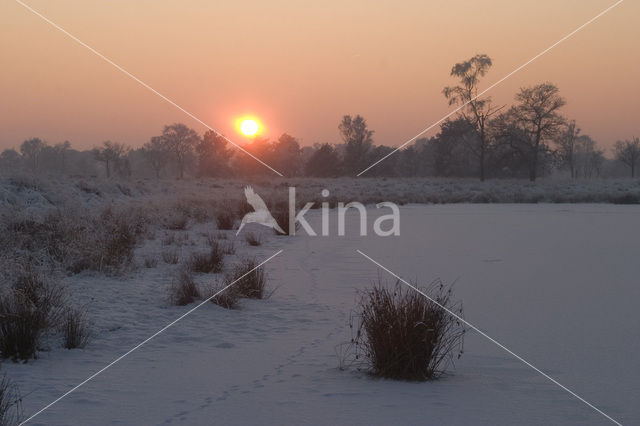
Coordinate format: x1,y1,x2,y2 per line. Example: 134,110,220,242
0,0,640,153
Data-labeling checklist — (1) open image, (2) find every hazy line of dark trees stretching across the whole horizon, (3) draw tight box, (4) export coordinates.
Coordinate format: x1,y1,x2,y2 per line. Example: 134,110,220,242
0,54,640,181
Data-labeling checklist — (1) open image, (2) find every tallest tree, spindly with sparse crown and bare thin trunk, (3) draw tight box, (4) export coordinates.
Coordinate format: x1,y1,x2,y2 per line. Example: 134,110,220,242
442,54,500,181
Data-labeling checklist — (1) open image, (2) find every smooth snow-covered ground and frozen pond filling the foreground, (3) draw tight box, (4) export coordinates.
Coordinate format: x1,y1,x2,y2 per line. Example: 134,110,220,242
2,200,640,425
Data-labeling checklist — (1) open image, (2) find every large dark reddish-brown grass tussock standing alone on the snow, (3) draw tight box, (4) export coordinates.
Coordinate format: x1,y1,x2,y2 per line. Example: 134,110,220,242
354,281,465,381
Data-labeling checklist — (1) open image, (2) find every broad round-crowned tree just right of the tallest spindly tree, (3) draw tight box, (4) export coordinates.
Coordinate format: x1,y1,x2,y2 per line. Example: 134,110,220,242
507,83,566,181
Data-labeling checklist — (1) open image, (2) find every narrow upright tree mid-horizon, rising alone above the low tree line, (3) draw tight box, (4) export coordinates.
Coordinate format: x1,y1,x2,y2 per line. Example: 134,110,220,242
338,115,374,174
